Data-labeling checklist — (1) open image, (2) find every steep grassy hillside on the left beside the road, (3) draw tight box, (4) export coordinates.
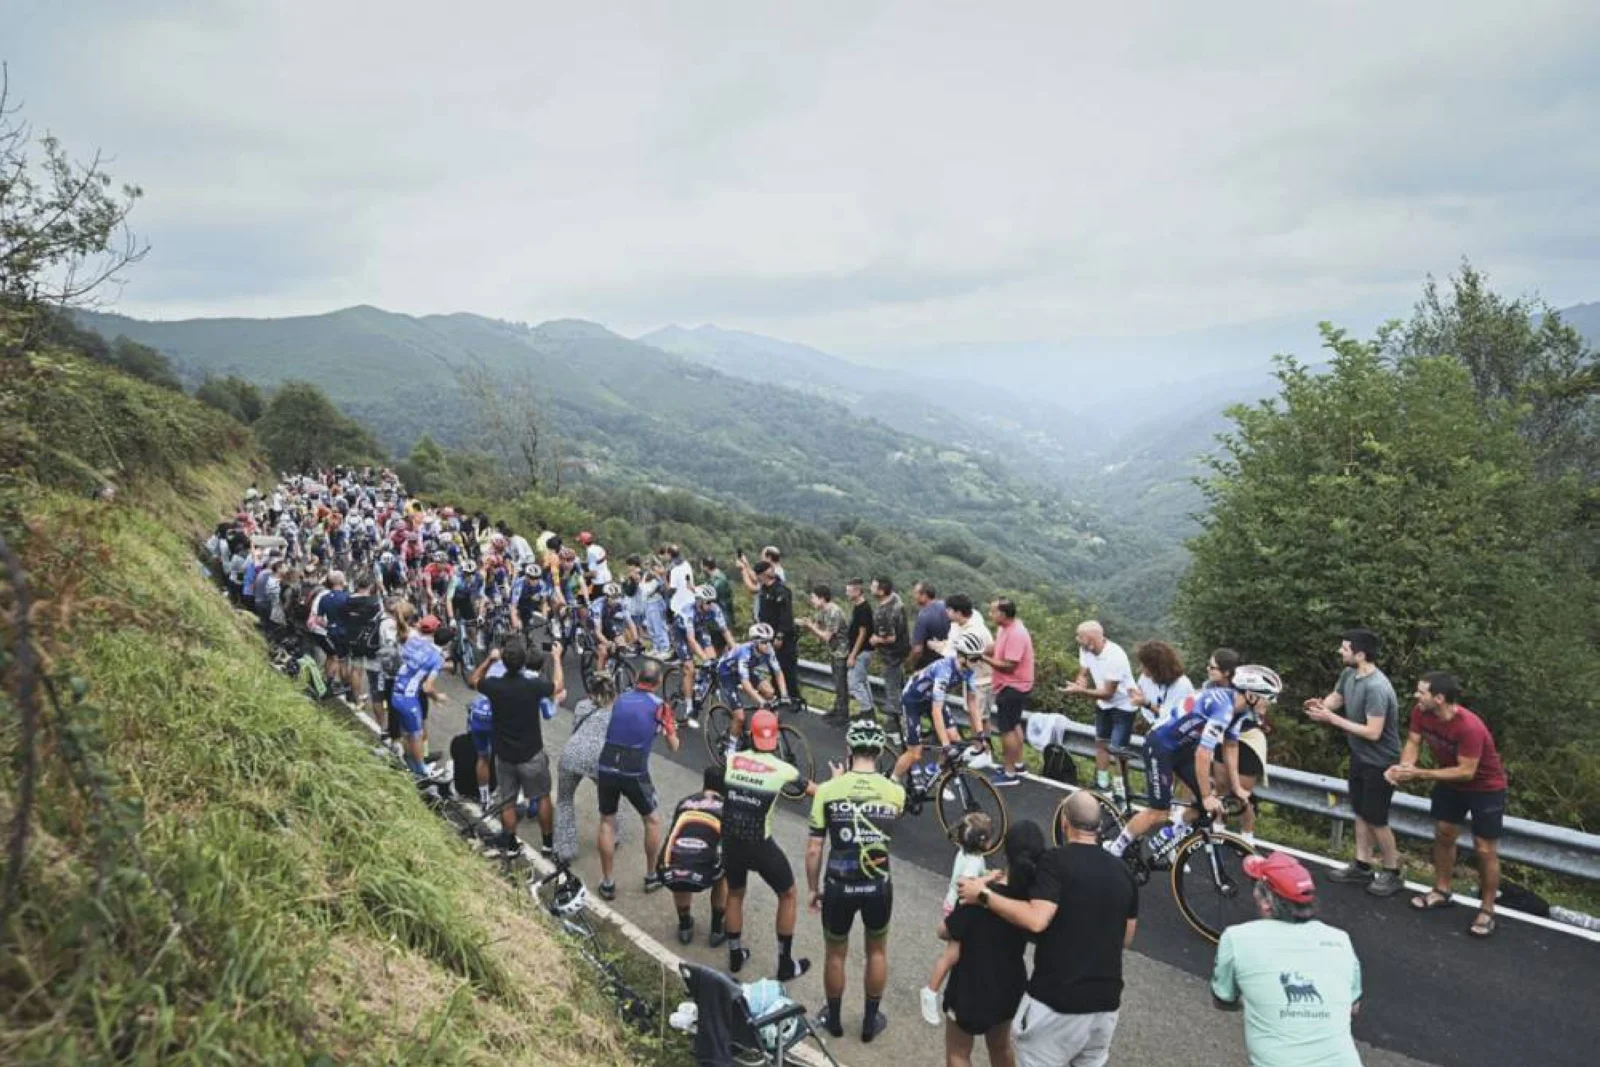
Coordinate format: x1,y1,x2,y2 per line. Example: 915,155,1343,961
0,348,650,1065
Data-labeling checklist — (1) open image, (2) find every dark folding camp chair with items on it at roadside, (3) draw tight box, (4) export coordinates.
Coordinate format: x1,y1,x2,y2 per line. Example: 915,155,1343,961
678,963,838,1067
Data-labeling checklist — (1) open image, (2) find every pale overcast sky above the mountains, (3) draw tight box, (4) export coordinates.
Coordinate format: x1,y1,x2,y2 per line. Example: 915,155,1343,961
9,0,1600,361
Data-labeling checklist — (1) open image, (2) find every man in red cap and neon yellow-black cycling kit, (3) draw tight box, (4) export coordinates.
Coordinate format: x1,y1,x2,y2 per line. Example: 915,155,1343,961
722,709,816,982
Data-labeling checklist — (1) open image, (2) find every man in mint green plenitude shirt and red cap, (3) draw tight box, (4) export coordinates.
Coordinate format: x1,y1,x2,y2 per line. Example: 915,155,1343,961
1211,853,1362,1067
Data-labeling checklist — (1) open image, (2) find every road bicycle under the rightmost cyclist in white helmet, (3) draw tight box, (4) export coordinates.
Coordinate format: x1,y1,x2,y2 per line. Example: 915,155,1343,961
1051,749,1259,942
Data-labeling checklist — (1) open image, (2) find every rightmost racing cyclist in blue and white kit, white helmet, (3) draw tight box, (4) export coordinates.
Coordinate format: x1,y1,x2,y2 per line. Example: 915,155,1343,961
1106,659,1283,856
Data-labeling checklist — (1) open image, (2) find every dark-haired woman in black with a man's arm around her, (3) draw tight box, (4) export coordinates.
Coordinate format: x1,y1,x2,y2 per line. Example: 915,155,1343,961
944,825,1046,1067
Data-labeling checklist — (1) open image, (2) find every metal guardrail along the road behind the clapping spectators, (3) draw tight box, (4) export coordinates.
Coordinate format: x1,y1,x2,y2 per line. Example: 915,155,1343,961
800,659,1600,881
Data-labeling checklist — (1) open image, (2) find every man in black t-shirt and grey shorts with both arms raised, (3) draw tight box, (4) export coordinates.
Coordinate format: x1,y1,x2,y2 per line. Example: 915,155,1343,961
470,640,565,851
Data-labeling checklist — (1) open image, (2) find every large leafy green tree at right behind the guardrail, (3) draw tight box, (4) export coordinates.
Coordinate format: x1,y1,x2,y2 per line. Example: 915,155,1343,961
1178,325,1600,824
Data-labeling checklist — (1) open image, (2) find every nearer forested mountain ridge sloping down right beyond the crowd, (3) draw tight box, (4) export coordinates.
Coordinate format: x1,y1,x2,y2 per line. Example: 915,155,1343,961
80,307,1165,625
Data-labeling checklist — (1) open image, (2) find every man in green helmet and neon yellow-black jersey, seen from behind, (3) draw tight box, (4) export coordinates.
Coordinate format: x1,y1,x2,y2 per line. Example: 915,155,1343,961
805,718,906,1041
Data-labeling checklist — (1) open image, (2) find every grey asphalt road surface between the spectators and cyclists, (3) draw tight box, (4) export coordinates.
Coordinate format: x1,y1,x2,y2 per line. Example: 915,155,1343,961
419,652,1600,1067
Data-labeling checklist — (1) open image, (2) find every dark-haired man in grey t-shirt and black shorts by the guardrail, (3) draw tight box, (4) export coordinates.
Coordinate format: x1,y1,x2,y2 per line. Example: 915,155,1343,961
1306,627,1405,896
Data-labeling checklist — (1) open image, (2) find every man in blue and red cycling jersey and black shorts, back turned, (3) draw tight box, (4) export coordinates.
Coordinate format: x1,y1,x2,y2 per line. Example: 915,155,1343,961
595,659,680,901
